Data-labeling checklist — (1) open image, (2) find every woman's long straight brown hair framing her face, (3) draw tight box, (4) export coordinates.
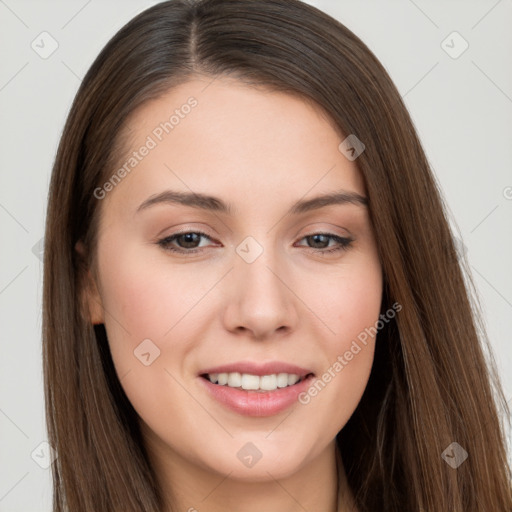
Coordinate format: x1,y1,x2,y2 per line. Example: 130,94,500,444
43,0,512,512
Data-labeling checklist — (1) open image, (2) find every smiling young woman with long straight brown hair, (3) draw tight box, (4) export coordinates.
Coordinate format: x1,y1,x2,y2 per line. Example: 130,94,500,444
43,0,512,512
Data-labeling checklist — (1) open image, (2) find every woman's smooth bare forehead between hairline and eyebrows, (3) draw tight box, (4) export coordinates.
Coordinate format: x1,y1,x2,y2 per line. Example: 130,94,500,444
102,77,365,217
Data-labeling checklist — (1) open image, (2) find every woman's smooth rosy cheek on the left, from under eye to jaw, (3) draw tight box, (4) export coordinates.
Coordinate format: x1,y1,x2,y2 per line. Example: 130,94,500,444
96,246,202,424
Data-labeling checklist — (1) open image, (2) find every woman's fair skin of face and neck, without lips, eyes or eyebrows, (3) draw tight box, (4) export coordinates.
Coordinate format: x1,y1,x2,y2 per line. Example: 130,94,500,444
82,76,382,512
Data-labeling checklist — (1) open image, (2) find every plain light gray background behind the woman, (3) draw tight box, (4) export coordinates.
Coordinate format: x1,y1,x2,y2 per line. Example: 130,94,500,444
0,0,512,512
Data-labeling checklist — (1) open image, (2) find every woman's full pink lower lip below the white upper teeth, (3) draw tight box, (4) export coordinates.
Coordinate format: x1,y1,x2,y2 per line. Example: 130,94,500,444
199,375,314,416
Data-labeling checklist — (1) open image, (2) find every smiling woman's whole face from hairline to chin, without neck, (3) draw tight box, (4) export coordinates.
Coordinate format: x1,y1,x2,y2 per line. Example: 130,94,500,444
84,74,382,480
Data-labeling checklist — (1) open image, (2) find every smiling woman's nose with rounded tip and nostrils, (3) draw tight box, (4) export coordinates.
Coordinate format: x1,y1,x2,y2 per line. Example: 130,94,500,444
223,244,300,340
